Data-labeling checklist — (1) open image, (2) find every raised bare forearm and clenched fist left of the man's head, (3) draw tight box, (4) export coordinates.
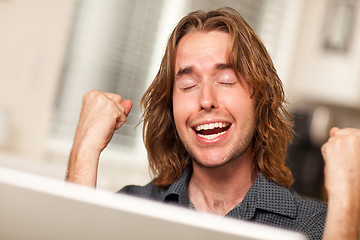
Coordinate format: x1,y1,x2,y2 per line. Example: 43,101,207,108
66,90,132,187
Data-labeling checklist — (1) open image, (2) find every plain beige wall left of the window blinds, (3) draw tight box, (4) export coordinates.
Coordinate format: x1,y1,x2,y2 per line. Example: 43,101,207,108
0,0,76,158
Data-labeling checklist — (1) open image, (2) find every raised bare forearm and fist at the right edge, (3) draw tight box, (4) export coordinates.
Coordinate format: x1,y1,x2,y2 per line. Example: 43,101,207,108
321,128,360,240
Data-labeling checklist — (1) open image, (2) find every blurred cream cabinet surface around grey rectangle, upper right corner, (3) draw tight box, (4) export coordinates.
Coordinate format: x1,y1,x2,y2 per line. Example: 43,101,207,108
287,0,360,107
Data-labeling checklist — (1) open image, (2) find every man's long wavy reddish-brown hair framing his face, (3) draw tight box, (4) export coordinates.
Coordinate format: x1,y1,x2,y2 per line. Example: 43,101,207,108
141,7,293,188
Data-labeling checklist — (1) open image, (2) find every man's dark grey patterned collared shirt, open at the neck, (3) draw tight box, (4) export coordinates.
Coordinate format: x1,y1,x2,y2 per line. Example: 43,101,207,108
120,166,327,239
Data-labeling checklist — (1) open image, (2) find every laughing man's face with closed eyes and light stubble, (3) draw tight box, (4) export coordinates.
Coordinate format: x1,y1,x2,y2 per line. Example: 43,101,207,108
173,31,255,167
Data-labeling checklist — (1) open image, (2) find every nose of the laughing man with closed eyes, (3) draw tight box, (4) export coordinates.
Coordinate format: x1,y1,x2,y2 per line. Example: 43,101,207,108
200,82,218,111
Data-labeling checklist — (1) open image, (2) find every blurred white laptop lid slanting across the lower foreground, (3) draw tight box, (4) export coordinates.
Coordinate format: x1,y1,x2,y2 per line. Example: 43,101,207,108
0,167,306,240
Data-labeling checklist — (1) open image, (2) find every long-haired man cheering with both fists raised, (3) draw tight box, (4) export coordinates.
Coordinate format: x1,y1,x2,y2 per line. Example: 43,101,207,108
67,8,360,239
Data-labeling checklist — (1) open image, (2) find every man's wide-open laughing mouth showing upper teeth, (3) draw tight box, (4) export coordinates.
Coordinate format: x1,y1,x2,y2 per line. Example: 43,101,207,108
194,122,231,140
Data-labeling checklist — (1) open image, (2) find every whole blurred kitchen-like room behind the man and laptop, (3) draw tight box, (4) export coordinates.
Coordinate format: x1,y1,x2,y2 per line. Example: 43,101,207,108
0,0,360,199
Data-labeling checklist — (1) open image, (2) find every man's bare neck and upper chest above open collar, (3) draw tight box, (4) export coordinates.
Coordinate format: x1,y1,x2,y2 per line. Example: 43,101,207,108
189,154,257,215
